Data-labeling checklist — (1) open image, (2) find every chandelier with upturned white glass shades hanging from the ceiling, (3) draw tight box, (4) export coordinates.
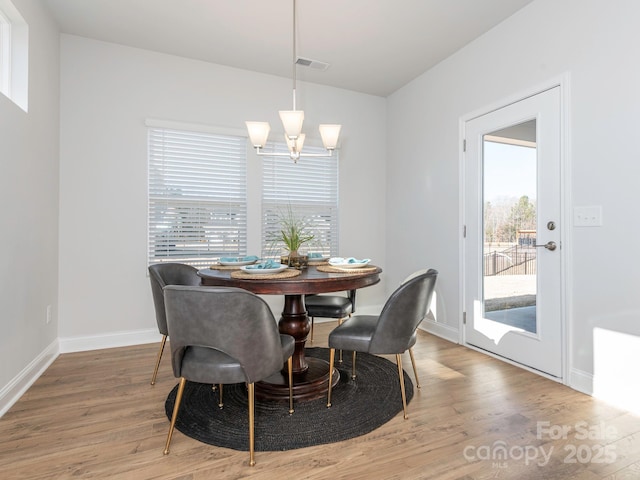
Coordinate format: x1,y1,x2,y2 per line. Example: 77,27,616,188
245,0,342,163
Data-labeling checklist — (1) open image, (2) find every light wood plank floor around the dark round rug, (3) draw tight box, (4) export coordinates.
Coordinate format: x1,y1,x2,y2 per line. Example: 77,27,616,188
0,323,640,480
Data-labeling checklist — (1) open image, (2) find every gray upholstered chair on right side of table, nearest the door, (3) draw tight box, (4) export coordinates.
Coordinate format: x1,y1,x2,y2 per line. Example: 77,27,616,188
327,269,438,419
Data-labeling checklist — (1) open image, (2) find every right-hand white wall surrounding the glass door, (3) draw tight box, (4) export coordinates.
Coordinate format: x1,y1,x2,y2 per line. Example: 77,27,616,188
387,0,640,403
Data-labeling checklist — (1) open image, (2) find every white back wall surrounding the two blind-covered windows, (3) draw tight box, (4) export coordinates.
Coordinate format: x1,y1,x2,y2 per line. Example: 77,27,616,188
59,35,386,350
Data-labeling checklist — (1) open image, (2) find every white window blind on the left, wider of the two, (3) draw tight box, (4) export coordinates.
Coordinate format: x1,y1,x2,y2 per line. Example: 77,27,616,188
148,127,247,267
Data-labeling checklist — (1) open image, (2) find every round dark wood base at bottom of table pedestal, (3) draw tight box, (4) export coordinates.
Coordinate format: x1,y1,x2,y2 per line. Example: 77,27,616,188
255,357,340,402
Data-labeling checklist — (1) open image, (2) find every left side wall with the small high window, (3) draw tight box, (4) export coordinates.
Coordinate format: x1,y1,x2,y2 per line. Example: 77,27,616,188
0,0,59,414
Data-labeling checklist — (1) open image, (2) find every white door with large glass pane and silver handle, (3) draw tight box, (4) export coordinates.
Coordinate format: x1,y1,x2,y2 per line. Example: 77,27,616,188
464,87,563,377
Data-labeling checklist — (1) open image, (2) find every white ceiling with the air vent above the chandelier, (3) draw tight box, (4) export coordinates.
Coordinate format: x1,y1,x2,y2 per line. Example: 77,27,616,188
42,0,533,97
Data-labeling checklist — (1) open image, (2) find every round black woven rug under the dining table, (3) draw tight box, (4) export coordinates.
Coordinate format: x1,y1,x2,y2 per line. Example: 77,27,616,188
165,348,413,452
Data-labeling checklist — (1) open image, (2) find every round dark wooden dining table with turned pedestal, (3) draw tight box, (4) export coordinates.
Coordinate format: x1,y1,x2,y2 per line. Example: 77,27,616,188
198,266,382,401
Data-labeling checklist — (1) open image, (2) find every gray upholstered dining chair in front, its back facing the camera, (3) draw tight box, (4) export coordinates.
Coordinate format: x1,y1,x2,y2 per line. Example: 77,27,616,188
164,285,295,466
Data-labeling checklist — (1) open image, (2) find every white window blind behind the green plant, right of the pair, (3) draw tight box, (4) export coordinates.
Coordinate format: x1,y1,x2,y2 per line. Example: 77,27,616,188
262,144,339,258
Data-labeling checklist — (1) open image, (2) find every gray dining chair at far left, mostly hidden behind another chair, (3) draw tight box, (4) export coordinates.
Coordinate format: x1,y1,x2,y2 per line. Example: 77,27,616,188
149,263,200,385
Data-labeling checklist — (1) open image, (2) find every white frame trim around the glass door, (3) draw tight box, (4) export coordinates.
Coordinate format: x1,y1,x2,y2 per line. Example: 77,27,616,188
458,73,573,384
